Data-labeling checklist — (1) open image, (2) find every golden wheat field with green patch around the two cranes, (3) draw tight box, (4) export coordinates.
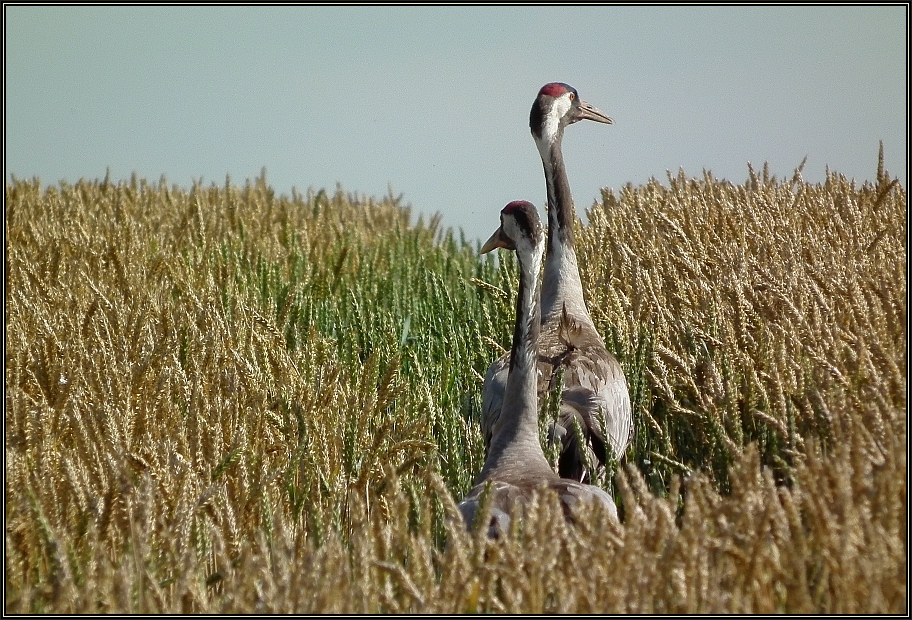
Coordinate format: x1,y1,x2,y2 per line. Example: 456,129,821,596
5,151,908,613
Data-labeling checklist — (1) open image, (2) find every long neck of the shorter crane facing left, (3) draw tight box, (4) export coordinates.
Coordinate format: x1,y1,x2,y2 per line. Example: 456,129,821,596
478,242,552,481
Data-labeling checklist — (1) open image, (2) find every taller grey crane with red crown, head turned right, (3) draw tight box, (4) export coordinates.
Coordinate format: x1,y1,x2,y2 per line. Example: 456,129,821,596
481,82,632,482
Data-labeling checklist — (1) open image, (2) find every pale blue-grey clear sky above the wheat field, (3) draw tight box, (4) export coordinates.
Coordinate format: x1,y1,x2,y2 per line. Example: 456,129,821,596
4,4,908,240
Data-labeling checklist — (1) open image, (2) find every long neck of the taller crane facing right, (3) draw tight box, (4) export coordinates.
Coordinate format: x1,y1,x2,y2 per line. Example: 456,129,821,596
536,130,592,323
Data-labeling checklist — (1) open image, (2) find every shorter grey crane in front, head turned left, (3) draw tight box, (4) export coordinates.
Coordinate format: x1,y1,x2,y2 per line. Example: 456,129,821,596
458,200,617,538
